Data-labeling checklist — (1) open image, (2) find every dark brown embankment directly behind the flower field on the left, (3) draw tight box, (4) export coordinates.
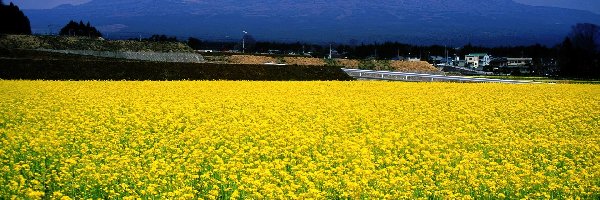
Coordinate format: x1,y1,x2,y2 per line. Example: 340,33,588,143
0,49,353,81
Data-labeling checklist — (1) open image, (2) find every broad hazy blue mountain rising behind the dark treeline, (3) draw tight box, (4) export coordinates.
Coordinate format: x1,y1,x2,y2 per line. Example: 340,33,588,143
25,0,600,46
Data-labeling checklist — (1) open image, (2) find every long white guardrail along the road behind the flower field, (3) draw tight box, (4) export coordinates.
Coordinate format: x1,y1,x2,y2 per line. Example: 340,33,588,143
342,68,541,84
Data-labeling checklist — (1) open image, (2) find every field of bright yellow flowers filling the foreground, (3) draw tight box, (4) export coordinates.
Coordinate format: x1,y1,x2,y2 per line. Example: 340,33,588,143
0,81,600,199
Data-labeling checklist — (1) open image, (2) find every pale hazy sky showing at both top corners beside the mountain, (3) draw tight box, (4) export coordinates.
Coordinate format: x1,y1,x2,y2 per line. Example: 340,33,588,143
4,0,600,14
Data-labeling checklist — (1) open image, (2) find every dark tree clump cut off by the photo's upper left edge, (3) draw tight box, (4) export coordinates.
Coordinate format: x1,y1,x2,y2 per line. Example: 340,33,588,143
0,0,31,35
